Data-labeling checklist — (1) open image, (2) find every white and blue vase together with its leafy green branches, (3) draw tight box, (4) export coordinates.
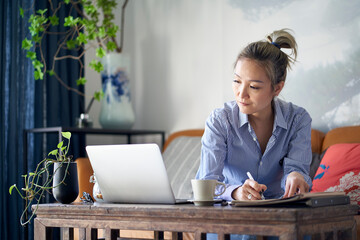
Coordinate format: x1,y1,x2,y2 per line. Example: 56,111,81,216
20,0,134,128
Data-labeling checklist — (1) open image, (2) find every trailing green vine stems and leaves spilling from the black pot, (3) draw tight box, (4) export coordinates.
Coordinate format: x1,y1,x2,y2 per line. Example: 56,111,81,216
9,132,77,225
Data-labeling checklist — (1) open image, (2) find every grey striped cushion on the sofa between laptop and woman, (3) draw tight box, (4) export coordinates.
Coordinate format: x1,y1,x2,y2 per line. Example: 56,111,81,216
163,136,201,199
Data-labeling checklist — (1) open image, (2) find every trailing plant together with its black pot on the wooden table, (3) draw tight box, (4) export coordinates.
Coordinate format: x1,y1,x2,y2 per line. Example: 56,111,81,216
9,132,79,225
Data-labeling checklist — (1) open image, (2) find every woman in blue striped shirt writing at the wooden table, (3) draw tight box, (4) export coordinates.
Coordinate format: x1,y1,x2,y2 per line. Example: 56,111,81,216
196,29,311,200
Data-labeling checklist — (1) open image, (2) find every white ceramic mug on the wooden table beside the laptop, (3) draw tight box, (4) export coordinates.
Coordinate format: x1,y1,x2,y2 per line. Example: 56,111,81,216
191,179,226,201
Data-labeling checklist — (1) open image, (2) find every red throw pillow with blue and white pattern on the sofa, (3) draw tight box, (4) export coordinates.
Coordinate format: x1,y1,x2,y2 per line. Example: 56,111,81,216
311,143,360,205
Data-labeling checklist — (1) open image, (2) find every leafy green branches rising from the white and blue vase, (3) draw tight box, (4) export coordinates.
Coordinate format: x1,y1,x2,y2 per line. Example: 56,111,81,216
20,0,128,110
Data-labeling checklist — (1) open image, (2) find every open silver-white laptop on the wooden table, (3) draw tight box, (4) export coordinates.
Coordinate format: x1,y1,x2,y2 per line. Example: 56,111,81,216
86,144,188,204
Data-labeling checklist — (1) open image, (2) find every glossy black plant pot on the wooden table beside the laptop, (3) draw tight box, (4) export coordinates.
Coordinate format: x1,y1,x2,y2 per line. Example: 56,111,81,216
52,162,79,204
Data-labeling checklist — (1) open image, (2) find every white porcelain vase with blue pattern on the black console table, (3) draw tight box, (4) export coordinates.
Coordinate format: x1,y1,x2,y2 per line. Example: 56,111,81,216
99,53,135,129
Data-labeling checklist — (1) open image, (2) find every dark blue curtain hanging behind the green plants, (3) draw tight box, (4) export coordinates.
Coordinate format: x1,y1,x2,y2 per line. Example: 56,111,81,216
0,0,84,239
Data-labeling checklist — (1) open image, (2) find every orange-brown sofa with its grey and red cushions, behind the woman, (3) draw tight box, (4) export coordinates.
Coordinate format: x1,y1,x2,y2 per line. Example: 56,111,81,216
77,126,360,239
